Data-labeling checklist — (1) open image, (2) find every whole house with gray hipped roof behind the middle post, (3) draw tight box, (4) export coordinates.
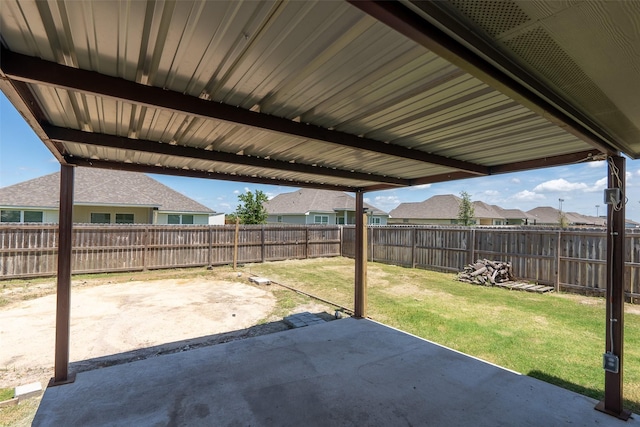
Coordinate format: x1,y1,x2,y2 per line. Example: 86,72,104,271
264,189,389,225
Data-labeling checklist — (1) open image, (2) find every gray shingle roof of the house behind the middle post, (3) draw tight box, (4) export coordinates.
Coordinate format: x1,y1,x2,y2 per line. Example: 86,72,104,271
264,189,387,215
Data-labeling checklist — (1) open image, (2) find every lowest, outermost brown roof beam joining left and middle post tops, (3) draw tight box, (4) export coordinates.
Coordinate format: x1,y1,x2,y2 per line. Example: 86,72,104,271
65,155,359,192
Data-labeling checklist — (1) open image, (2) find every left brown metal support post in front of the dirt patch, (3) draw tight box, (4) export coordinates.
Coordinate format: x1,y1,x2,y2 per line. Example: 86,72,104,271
49,165,75,386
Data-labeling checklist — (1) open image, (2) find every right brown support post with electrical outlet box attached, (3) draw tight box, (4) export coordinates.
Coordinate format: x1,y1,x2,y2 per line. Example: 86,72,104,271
596,156,631,420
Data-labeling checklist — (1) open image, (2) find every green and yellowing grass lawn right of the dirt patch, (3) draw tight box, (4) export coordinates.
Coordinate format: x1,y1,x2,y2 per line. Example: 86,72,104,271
251,258,640,413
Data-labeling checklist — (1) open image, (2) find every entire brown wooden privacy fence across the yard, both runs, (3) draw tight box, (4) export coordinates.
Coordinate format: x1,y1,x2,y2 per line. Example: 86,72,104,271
0,224,640,298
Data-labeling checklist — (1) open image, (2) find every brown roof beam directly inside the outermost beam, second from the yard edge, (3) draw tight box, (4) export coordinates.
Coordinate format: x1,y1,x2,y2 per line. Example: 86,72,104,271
42,125,411,186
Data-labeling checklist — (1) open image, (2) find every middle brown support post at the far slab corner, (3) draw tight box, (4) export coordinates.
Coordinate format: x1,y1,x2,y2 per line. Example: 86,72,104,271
354,191,367,318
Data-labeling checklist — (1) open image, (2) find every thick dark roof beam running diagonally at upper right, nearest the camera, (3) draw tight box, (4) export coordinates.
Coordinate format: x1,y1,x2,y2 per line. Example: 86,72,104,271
347,0,618,154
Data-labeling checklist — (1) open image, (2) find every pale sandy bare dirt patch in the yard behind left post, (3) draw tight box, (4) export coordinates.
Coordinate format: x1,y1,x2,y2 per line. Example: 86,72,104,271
0,278,276,386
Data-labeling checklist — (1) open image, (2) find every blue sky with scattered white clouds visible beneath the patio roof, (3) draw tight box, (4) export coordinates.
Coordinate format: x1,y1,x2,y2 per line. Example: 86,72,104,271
0,94,640,222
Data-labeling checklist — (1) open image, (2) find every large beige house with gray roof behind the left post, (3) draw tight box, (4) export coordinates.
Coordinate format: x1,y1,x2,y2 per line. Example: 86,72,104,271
0,167,215,224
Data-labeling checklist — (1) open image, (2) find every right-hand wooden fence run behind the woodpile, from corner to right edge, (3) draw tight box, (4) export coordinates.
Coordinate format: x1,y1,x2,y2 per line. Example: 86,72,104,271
342,226,640,298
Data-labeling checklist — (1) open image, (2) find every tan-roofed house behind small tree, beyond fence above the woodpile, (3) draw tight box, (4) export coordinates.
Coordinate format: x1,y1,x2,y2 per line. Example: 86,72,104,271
389,194,507,225
